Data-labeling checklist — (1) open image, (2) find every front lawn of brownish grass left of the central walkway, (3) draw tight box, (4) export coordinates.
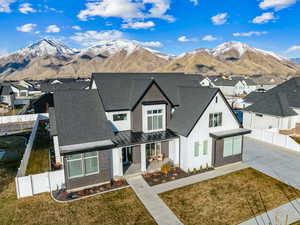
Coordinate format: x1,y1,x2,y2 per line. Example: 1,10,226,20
0,165,156,225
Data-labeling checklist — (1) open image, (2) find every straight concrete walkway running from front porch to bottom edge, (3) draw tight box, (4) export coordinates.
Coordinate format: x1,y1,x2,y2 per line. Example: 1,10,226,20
127,176,183,225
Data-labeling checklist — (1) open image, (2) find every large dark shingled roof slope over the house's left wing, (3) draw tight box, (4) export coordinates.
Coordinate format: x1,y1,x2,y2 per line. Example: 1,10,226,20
54,90,114,146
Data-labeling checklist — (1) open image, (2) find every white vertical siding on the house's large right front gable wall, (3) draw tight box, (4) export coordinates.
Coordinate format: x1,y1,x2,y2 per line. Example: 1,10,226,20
180,93,240,171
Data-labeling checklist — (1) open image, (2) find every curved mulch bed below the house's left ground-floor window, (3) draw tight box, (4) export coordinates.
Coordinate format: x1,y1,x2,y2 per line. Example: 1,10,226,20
53,180,128,202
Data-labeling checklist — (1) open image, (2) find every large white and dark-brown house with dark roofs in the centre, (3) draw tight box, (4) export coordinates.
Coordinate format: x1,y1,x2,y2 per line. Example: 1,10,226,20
49,73,250,190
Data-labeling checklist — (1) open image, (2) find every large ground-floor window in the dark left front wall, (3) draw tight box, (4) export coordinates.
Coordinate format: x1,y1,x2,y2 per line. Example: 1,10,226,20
67,152,99,178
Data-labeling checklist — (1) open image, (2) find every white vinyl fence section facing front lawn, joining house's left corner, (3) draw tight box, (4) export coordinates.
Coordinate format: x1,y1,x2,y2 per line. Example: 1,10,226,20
15,170,65,198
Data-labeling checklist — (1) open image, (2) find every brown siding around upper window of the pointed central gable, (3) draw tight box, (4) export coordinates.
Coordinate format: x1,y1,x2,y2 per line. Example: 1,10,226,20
131,83,171,132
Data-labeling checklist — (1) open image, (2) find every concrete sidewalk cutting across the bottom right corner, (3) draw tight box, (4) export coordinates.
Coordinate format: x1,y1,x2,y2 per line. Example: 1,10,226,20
239,199,300,225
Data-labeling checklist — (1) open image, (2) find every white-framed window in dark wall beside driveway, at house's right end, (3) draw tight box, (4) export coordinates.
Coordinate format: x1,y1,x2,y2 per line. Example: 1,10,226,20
223,136,242,157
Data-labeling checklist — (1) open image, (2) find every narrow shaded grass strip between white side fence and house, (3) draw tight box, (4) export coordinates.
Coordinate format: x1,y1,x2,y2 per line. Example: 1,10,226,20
26,122,52,175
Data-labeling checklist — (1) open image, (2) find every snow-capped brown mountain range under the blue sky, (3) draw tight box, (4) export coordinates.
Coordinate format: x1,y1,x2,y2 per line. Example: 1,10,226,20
0,38,300,80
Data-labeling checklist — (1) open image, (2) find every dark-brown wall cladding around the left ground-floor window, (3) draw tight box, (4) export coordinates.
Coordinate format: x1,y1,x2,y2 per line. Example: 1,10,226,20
64,149,113,190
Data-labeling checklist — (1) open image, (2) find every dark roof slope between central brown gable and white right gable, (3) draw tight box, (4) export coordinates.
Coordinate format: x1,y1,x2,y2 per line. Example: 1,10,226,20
168,87,219,136
